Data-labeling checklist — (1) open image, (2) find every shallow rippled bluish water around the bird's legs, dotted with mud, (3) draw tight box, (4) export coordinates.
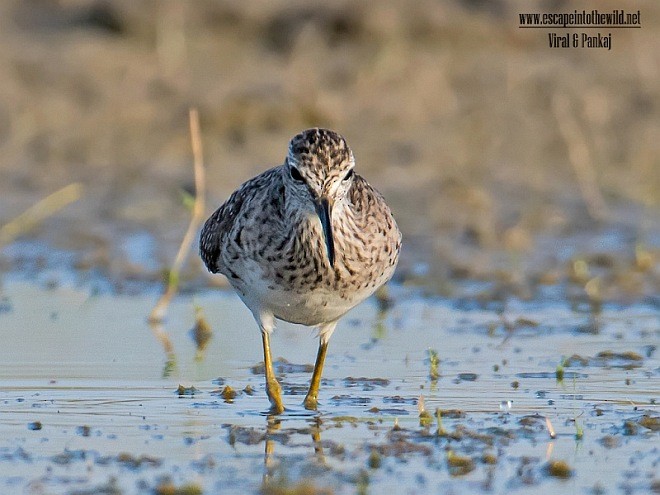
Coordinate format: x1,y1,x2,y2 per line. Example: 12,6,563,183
0,281,660,493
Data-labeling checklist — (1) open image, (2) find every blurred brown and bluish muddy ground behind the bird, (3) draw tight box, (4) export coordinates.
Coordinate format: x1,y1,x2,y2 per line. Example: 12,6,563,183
0,0,660,300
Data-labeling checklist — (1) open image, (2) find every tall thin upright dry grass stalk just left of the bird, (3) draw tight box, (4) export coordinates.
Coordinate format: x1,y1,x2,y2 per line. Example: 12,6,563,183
149,108,206,322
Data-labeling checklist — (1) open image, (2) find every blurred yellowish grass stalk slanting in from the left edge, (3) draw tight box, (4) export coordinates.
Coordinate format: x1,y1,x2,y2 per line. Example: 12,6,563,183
0,182,84,246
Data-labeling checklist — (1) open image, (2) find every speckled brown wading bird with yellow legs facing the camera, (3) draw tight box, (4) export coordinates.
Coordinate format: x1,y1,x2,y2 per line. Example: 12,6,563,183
199,128,402,414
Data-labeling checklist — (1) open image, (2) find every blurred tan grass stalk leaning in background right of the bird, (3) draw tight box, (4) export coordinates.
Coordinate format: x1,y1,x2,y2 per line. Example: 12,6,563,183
552,95,607,220
